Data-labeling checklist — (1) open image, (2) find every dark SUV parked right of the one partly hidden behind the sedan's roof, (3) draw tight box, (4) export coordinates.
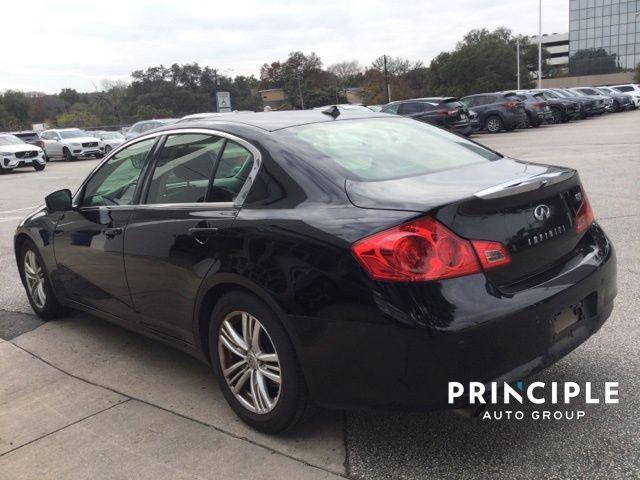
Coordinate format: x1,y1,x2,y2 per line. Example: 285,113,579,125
461,92,527,133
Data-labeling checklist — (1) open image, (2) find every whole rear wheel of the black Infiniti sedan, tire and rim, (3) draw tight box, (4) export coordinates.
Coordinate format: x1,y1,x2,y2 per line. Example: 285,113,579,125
209,291,310,433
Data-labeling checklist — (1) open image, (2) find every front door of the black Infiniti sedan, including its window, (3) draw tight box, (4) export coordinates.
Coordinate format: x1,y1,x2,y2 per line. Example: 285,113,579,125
54,139,155,319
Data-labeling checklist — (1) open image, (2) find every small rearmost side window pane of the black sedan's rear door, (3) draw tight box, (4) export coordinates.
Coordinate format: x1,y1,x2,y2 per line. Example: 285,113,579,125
211,140,254,202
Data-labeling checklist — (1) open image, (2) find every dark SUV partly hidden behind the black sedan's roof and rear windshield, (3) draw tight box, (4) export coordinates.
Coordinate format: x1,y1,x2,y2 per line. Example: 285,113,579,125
381,97,473,135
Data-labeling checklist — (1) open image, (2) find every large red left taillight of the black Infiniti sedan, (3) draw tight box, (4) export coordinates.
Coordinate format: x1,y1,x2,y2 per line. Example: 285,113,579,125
351,217,508,282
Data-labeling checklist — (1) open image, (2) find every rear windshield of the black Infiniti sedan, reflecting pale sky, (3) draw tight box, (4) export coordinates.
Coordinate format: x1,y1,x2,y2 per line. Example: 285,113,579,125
277,117,501,181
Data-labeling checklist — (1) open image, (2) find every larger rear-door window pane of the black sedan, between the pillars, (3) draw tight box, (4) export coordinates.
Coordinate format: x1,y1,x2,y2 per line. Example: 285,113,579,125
146,134,224,204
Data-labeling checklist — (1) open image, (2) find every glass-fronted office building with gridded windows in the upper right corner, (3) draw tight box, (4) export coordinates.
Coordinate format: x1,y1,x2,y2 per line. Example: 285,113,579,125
569,0,640,75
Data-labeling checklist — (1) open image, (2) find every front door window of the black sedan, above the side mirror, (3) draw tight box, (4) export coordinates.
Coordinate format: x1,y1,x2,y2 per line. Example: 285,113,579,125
82,138,155,207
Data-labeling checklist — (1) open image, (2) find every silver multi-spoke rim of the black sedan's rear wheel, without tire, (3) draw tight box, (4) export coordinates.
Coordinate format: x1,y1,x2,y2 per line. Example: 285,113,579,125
218,311,282,414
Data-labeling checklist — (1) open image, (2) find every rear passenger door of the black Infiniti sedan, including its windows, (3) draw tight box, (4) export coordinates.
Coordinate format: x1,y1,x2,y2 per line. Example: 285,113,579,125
124,131,257,343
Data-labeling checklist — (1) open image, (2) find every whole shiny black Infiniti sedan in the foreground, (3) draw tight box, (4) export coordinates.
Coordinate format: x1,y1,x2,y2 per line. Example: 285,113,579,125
15,109,616,432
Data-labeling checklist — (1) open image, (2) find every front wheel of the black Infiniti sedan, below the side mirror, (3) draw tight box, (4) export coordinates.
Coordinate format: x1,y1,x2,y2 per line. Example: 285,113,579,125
19,240,66,320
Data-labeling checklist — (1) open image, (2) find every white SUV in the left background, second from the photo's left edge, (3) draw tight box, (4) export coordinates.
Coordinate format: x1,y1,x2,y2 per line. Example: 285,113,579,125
40,128,104,161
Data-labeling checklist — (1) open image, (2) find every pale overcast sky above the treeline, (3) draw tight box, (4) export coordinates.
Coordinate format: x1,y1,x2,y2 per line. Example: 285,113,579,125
0,0,569,93
